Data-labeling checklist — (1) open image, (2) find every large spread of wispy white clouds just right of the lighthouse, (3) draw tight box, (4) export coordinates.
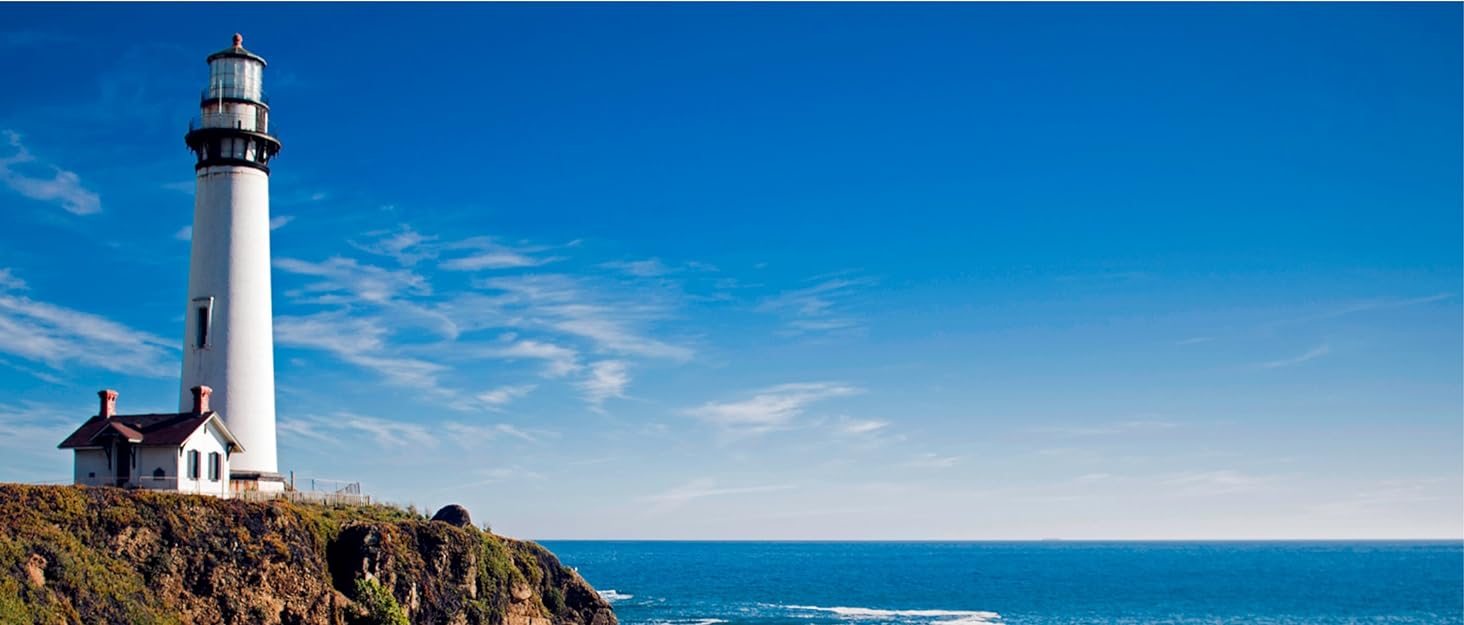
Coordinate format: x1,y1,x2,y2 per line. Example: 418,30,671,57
275,225,694,408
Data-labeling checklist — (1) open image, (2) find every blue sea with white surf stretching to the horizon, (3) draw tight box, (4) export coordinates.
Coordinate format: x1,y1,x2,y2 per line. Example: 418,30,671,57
543,540,1464,625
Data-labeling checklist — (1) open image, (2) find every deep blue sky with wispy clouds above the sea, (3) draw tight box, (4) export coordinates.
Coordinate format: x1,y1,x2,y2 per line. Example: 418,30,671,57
0,3,1464,539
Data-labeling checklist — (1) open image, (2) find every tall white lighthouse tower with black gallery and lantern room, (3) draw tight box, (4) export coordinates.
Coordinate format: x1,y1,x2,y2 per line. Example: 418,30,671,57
179,35,284,490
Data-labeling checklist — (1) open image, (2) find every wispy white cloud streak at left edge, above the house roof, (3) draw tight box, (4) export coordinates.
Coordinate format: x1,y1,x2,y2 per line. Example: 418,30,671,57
0,278,177,378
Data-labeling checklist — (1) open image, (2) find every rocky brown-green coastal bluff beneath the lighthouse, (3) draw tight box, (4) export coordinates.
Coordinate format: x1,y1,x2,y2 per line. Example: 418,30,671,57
0,484,616,625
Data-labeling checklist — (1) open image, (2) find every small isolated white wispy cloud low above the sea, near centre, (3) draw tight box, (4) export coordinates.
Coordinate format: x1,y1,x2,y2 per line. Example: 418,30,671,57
687,382,862,435
